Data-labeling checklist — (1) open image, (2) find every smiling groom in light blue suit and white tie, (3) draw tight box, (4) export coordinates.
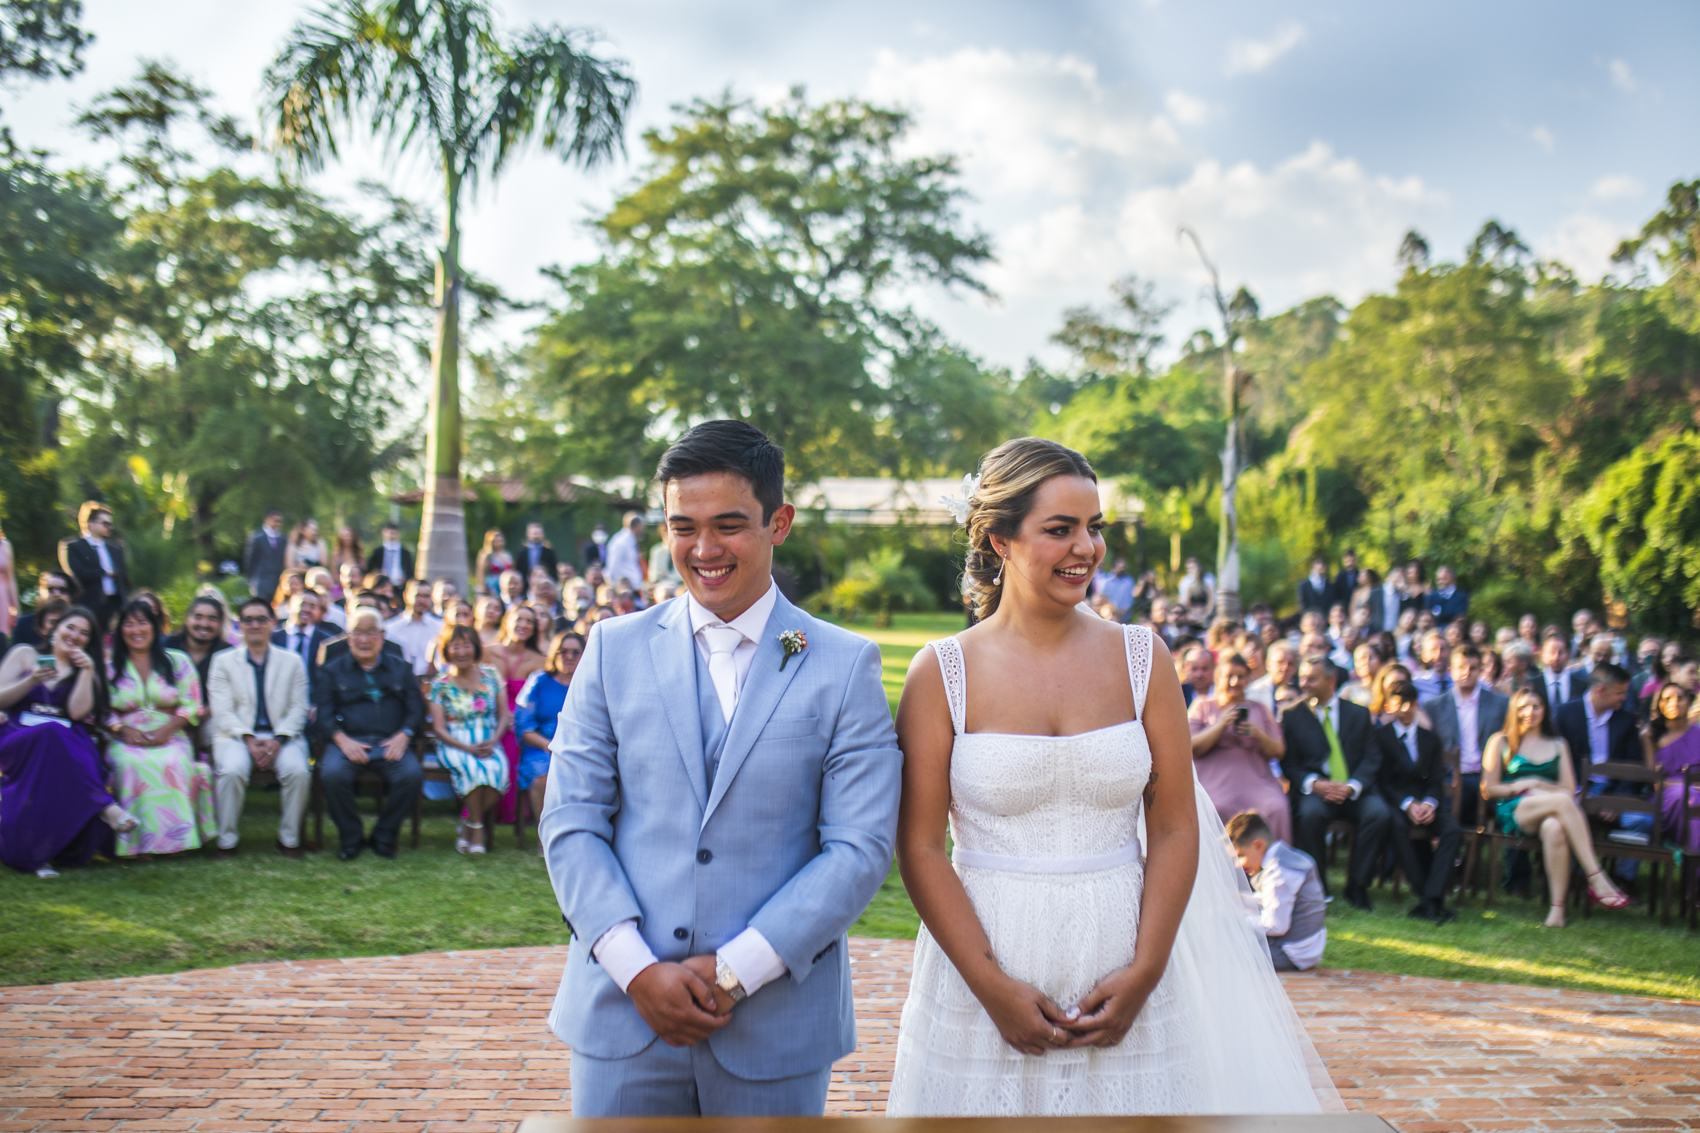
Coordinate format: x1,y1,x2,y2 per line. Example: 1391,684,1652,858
537,420,903,1118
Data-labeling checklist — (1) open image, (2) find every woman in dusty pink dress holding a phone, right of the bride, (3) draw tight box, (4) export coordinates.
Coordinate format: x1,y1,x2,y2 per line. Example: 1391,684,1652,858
1187,653,1292,844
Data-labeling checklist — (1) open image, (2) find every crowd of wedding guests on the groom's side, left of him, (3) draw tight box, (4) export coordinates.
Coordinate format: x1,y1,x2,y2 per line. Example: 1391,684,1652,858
0,504,677,878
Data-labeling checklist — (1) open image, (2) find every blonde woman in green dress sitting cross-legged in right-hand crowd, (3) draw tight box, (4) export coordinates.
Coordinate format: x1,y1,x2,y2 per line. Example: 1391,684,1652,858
1482,687,1629,929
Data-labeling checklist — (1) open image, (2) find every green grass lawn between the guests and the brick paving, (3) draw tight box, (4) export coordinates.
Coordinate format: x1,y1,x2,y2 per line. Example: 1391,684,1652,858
0,614,1700,999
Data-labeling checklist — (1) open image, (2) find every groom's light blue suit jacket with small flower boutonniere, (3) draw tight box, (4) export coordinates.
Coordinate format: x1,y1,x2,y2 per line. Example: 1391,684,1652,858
537,585,903,1080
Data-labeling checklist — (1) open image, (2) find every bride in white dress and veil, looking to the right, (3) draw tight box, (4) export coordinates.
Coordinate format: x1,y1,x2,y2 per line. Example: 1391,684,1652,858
887,439,1340,1116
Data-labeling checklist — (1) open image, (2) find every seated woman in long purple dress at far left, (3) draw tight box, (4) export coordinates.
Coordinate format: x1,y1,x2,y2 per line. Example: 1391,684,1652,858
0,606,136,878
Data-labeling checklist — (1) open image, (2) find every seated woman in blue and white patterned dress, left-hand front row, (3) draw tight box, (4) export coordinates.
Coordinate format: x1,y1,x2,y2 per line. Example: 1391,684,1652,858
428,626,513,854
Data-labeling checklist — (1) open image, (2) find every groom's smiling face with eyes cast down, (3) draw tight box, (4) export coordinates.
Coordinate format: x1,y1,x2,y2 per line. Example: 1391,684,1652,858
663,473,796,621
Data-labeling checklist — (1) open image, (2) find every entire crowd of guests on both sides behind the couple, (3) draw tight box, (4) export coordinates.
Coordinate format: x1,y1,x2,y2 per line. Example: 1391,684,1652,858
0,505,1700,918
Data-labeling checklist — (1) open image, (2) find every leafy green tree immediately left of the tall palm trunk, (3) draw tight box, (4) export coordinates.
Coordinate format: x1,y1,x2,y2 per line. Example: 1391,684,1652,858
53,65,430,561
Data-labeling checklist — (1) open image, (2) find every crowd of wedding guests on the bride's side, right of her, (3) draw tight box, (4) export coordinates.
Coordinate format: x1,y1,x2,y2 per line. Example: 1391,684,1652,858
1093,555,1700,925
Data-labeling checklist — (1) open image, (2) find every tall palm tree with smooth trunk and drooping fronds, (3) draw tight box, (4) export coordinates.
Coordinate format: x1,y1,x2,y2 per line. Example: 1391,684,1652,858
265,0,636,594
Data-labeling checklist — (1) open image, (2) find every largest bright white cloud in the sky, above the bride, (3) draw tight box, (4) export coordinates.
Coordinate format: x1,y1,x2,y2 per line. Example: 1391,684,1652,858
865,49,1447,369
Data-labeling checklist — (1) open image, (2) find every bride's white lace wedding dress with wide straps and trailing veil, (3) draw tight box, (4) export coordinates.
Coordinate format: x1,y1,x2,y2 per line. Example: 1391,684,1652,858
886,626,1340,1116
